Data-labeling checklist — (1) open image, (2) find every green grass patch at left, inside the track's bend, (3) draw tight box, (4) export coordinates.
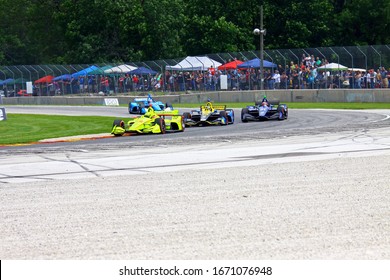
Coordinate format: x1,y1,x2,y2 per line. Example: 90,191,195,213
0,114,114,145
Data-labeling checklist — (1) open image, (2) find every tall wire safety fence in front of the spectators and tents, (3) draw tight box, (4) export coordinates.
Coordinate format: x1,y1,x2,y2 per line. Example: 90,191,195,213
0,45,390,97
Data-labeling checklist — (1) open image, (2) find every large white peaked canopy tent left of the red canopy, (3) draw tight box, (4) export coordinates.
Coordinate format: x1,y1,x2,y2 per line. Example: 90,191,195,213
165,56,222,71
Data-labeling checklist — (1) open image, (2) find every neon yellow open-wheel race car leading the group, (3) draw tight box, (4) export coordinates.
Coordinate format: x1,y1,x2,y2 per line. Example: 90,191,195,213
111,107,185,136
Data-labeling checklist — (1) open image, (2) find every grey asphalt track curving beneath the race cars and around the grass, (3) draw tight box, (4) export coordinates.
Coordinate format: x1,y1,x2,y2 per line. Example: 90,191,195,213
0,106,390,153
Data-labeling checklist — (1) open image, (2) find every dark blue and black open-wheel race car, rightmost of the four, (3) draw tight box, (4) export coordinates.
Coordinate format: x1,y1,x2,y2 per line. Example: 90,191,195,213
241,100,288,122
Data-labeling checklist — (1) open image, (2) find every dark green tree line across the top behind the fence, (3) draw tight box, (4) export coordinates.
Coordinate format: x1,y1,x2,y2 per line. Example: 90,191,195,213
0,0,390,65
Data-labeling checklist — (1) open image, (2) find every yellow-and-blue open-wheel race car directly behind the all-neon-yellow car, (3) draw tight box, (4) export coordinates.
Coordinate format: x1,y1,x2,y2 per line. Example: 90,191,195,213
183,102,234,126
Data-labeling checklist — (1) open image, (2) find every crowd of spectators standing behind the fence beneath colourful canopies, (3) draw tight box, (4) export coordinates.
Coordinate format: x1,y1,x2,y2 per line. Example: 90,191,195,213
5,54,390,95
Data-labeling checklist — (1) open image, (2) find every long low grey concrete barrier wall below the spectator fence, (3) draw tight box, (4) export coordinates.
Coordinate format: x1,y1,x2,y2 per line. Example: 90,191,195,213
2,89,390,105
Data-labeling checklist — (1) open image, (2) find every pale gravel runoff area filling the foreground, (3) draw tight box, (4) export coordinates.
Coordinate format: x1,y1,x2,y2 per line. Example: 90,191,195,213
0,132,390,260
